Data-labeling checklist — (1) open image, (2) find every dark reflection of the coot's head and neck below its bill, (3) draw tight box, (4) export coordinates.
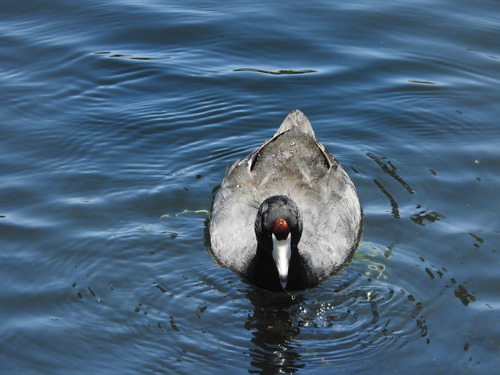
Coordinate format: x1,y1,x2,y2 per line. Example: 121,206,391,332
245,286,305,374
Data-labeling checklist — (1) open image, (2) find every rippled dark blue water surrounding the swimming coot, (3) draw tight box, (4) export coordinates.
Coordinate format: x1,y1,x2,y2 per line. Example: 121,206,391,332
0,0,500,374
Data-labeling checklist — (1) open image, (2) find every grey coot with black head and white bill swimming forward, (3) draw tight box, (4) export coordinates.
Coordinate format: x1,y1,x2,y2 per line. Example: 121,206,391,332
209,110,363,291
